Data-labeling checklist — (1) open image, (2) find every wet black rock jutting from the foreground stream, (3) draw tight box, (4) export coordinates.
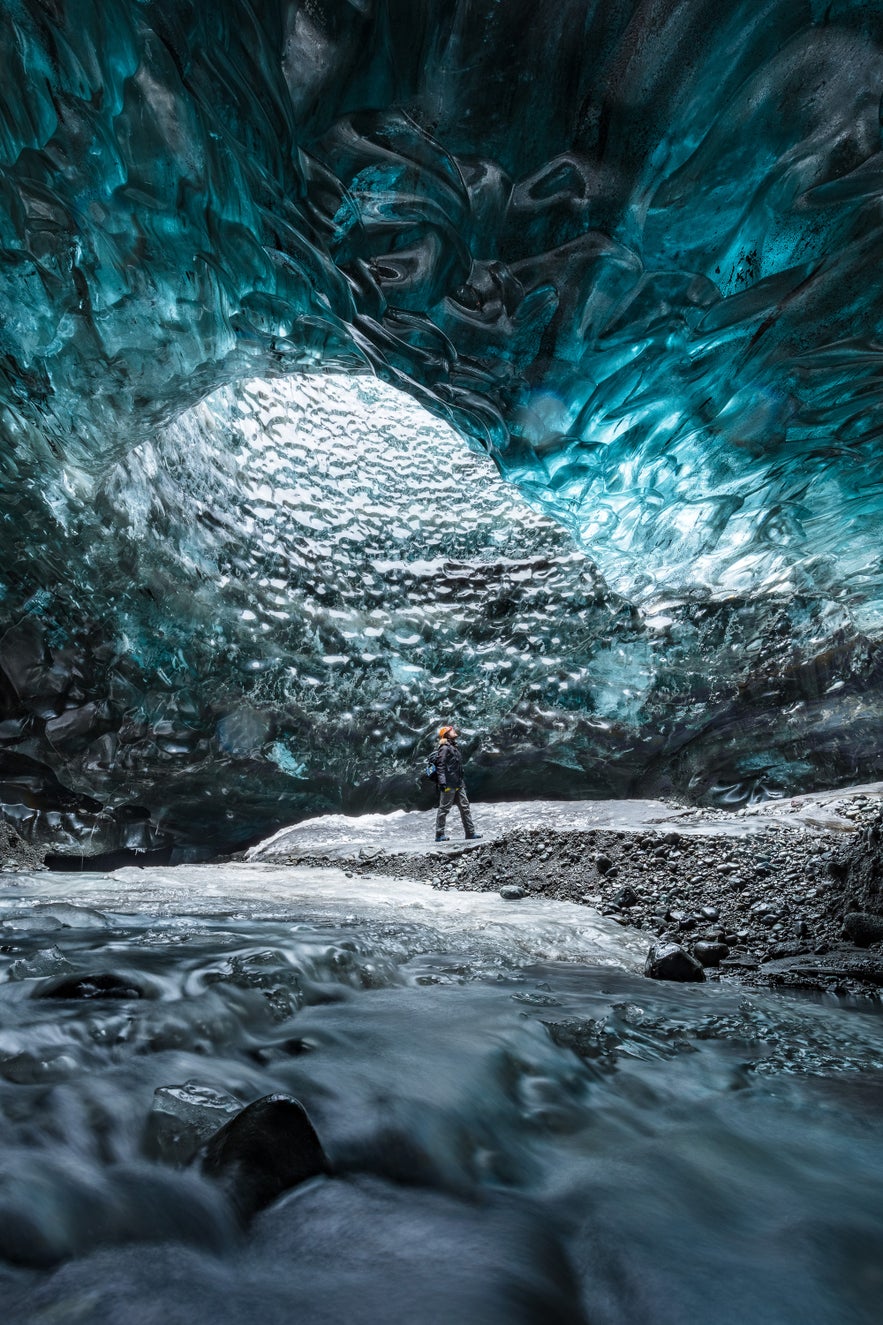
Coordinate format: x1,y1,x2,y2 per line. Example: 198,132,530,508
202,1094,329,1220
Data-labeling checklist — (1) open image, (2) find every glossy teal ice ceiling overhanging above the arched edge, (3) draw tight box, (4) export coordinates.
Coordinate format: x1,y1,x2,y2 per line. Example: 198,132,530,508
0,0,883,598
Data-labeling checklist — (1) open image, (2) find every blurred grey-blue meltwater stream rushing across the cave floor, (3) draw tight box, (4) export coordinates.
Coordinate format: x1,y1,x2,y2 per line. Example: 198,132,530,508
0,865,883,1325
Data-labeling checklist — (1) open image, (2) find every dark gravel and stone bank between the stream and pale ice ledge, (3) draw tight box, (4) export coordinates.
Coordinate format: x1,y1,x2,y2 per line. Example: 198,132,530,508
277,795,883,999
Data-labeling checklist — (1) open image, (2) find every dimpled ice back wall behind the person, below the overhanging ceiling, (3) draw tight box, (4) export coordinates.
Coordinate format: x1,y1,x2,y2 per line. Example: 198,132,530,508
0,376,880,855
